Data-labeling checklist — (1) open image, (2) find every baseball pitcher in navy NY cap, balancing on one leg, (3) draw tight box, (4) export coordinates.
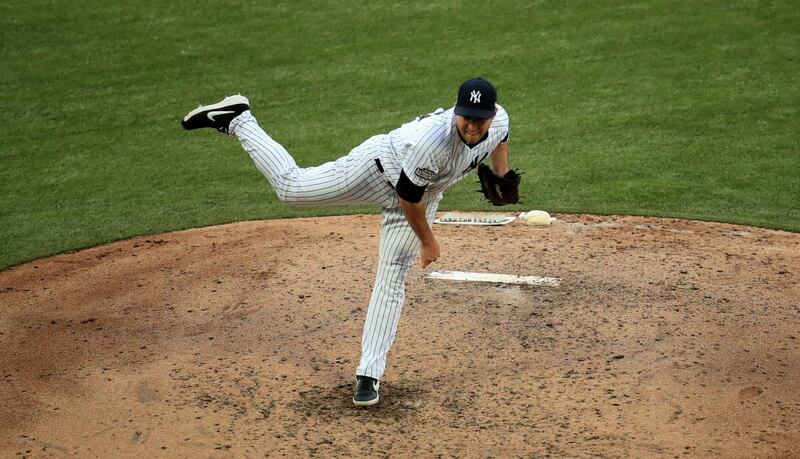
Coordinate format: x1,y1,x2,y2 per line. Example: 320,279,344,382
181,78,520,406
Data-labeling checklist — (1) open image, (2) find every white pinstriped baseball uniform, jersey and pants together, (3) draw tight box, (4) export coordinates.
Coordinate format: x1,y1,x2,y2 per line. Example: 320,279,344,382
229,105,509,380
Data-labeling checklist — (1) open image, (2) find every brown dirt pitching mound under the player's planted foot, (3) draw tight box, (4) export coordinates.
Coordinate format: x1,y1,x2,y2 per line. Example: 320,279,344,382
0,214,800,457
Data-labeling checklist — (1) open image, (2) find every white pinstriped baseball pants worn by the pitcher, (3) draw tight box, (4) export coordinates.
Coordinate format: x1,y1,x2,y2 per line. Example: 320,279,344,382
229,111,441,379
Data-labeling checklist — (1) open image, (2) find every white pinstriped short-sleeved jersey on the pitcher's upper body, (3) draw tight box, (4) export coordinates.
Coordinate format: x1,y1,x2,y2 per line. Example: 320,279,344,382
380,105,509,199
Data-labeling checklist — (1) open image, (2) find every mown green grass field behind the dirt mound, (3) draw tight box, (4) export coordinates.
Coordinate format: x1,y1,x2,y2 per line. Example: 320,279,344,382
0,0,800,269
